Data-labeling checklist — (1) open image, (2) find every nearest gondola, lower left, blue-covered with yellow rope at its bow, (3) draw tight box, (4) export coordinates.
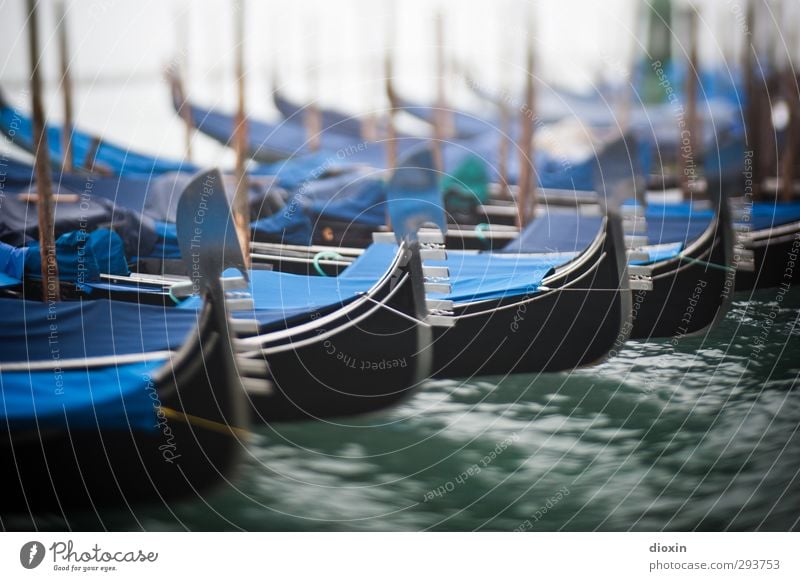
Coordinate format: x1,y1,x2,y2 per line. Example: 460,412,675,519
0,170,255,516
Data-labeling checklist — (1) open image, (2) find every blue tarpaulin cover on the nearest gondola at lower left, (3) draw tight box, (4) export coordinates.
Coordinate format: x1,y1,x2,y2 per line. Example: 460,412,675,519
0,299,197,429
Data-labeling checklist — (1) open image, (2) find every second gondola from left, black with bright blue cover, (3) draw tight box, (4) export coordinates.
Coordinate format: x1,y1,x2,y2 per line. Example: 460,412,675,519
166,154,452,422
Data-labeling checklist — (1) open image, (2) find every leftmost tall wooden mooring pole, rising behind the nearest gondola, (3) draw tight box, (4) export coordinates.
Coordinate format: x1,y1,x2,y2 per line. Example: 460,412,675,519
28,0,61,302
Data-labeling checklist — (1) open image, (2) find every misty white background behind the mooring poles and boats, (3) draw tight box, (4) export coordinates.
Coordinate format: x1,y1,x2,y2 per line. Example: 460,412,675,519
0,0,776,165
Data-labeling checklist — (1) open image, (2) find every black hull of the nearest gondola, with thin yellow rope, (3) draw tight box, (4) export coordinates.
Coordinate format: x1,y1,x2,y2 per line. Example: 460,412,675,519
0,296,247,518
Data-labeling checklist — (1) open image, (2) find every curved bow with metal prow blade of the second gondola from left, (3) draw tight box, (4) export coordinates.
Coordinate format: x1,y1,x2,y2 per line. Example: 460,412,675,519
238,149,450,421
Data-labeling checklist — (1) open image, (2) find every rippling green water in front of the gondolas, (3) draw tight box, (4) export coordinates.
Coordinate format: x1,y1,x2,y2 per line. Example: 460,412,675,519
14,289,800,531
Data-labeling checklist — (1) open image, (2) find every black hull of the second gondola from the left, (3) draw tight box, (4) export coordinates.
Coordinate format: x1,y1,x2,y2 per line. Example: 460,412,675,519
245,258,432,422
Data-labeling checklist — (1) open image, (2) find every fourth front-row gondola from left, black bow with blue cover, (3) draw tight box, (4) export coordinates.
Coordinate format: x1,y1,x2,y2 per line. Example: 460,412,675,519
468,139,735,339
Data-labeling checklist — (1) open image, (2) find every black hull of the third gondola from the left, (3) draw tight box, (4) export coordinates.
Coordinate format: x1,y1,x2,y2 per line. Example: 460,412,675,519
434,218,631,377
